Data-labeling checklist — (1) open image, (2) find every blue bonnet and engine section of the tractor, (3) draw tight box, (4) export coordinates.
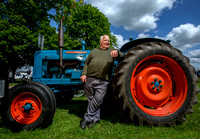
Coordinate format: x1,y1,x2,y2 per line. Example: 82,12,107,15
33,50,90,92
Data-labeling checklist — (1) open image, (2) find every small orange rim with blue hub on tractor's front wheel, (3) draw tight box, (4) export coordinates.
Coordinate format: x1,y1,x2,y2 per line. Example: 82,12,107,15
10,92,42,124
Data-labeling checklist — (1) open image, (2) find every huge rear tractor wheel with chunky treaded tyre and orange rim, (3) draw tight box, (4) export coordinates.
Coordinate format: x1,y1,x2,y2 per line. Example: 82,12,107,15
113,42,199,126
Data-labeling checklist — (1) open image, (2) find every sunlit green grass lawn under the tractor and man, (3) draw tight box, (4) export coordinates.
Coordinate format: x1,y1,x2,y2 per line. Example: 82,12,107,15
0,81,200,139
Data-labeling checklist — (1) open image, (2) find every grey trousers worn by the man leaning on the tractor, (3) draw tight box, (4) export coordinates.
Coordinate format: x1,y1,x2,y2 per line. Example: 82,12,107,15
84,77,109,122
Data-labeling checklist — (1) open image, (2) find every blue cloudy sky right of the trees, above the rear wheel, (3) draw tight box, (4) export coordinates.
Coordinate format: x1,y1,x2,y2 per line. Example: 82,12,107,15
50,0,200,70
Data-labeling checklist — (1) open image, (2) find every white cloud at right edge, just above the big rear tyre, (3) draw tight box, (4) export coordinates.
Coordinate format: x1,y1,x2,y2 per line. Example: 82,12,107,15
155,23,200,70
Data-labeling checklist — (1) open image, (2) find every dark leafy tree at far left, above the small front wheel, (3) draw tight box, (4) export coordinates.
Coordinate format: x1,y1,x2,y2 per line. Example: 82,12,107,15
0,0,55,78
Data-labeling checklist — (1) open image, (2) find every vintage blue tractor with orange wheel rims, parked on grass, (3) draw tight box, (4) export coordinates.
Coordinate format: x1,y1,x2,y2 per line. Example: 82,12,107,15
2,20,199,129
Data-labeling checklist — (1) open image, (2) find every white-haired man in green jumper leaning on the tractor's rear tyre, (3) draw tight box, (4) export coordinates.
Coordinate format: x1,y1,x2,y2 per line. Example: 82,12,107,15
80,35,124,130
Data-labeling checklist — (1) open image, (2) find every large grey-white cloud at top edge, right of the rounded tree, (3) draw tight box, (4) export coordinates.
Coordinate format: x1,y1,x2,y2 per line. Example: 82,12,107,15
85,0,176,32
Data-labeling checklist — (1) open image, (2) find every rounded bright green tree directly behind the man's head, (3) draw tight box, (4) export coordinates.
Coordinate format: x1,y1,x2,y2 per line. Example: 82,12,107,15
63,4,116,49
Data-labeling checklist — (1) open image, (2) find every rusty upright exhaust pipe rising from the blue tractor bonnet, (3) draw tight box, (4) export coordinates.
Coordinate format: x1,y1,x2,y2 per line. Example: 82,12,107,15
58,19,64,68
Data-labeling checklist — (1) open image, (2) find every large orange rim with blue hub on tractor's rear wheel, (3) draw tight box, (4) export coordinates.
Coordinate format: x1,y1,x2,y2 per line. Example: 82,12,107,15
130,55,188,116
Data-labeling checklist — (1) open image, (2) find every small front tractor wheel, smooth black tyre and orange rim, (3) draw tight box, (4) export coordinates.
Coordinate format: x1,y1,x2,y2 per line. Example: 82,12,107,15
1,82,56,131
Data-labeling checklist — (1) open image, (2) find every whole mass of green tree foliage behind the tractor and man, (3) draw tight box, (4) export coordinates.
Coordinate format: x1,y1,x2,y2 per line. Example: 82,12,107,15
0,0,116,75
